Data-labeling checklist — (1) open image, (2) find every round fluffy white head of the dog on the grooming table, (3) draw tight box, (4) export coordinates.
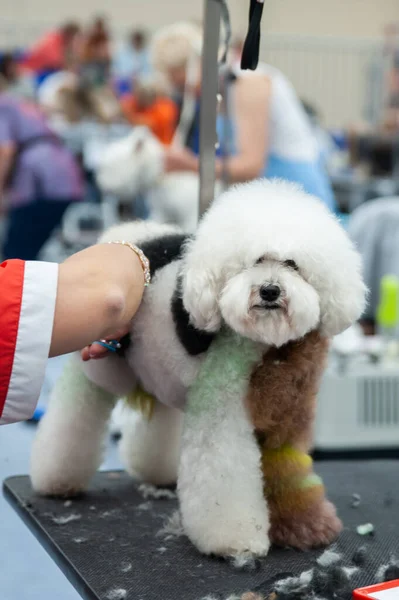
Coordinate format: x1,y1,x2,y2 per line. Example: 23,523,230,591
183,180,366,346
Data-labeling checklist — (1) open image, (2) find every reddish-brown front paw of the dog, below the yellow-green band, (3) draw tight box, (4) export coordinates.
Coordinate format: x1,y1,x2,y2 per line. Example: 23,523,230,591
270,500,342,550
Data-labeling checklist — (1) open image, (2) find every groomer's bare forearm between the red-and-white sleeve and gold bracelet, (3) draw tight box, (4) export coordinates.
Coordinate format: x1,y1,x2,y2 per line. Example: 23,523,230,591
49,244,144,356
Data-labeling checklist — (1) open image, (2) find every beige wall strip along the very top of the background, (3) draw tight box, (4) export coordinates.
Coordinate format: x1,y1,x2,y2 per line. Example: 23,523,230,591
0,0,399,41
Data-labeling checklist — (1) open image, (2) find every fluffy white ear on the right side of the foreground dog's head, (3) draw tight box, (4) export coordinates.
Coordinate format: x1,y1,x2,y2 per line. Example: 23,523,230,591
320,252,367,337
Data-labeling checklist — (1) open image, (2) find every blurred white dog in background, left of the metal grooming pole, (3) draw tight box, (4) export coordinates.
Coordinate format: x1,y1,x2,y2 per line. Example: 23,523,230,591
96,127,221,233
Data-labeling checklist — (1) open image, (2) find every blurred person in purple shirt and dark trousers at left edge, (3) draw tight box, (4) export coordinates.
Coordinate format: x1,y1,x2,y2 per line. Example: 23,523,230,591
0,92,83,260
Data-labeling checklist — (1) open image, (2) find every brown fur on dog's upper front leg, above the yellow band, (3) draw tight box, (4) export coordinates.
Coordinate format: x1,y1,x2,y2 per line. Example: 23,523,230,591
247,331,329,451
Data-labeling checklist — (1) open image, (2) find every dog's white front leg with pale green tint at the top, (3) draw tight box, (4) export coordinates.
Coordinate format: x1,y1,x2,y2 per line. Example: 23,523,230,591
178,334,269,556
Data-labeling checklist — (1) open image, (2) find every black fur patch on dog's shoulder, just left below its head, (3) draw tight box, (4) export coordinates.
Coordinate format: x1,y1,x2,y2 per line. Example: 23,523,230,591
171,278,215,356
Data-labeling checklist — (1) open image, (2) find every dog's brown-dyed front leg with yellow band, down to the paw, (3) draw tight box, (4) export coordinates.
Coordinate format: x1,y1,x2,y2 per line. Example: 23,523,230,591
247,331,342,549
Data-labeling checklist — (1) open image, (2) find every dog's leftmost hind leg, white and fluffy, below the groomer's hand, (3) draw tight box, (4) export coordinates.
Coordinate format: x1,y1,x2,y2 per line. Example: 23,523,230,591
31,356,115,496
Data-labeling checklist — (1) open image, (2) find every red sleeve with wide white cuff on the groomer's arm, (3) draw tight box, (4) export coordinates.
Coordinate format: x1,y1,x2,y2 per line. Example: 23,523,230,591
0,260,58,425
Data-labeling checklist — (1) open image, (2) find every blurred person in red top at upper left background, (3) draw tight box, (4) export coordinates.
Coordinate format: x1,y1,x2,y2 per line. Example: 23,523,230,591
22,21,82,80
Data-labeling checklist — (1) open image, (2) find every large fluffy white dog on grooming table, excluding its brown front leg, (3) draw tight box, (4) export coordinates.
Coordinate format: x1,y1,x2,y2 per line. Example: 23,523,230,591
31,181,365,555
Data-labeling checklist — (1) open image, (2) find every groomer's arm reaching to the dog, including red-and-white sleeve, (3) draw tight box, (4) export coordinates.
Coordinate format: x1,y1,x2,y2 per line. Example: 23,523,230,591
0,244,144,425
